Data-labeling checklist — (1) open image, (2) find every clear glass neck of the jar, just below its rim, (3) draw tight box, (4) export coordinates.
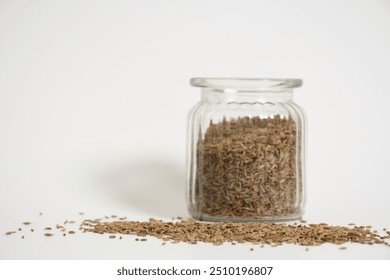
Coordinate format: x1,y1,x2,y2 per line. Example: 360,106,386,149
202,88,293,103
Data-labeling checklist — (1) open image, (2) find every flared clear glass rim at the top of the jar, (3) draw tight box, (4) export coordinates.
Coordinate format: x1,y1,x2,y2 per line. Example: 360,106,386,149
190,78,302,92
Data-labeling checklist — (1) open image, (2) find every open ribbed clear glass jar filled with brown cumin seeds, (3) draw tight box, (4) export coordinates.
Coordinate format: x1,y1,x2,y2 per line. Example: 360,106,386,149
186,78,305,221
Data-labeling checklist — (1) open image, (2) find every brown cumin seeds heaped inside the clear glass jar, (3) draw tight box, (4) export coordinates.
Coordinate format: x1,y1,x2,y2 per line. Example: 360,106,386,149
195,115,302,218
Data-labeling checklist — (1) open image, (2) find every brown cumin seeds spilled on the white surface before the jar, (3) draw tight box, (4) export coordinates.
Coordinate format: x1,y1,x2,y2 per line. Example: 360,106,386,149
81,219,390,246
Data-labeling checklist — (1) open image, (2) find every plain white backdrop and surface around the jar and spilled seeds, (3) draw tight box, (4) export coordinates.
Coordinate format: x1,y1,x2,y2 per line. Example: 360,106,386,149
0,0,390,259
